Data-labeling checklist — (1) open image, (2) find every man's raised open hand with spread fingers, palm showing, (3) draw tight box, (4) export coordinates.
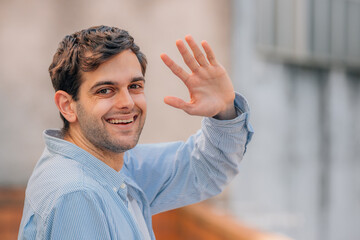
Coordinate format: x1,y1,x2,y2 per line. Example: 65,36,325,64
160,35,236,120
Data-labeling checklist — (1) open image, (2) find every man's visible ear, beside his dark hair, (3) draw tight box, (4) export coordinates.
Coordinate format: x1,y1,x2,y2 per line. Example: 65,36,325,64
54,90,77,123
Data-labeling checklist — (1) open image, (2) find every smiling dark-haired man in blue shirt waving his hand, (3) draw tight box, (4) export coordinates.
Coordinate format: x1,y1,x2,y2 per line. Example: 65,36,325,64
18,26,252,240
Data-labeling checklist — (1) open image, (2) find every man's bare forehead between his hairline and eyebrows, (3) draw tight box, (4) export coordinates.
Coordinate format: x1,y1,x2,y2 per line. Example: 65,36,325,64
81,50,143,85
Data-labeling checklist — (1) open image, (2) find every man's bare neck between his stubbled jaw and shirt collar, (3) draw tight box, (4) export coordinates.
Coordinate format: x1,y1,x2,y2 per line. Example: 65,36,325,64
64,129,124,172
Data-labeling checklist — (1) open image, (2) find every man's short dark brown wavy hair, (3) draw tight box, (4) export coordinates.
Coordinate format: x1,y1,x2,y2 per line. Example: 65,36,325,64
49,26,147,132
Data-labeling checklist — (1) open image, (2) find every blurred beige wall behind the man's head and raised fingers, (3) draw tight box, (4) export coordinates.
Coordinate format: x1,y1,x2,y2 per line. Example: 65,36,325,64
0,0,230,185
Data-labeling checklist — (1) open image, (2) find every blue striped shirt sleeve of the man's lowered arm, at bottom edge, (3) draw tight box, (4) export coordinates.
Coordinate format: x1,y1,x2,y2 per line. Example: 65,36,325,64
44,191,110,240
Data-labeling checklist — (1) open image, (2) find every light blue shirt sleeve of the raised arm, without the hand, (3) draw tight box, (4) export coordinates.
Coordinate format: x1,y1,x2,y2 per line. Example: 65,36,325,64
126,94,253,214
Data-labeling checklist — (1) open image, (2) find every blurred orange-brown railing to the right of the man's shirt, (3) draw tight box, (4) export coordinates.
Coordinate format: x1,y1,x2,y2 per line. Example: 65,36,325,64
153,203,289,240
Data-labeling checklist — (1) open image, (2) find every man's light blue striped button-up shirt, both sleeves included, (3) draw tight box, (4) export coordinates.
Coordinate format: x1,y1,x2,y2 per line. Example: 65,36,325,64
18,94,253,240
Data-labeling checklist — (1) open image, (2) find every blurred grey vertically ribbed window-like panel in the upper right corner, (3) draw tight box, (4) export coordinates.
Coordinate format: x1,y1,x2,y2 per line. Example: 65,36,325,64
257,0,360,68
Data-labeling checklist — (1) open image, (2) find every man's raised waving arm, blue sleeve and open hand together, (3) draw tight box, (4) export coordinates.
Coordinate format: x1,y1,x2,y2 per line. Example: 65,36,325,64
122,36,253,214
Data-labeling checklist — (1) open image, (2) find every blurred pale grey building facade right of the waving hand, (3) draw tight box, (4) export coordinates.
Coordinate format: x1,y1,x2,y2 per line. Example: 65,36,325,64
229,0,360,240
